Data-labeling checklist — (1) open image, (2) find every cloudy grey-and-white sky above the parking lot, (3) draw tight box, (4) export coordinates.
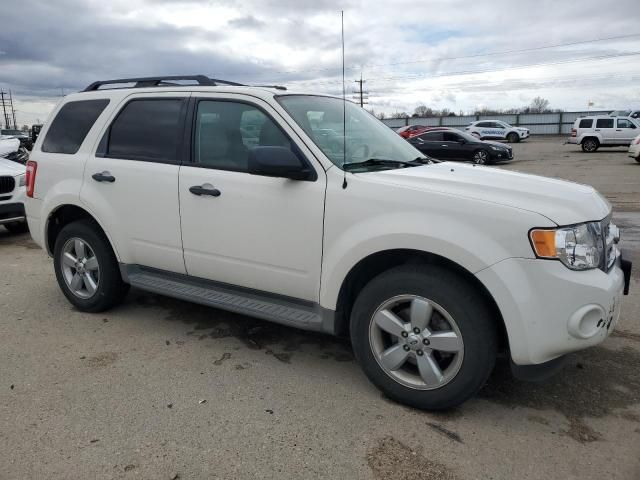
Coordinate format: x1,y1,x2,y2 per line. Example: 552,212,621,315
0,0,640,124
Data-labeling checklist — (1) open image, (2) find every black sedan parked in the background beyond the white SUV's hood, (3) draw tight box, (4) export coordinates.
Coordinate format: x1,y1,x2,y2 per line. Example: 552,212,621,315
407,129,513,164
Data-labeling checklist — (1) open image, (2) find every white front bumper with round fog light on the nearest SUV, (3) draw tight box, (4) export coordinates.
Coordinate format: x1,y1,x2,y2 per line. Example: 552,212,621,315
476,258,631,365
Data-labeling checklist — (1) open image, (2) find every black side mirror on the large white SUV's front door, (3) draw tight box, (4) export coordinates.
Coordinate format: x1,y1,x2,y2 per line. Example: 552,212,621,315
248,147,317,181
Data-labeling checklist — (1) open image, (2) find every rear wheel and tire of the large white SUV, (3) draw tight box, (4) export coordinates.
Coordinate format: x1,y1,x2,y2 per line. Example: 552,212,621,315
53,220,129,313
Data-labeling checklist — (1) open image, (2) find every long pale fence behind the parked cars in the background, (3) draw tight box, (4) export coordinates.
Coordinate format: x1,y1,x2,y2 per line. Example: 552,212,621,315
382,111,609,135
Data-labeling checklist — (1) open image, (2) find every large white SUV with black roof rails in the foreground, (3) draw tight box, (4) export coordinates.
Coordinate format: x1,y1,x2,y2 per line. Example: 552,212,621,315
22,76,631,409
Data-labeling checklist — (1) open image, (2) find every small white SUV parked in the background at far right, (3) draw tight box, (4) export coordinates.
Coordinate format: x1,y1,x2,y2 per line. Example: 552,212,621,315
568,115,640,152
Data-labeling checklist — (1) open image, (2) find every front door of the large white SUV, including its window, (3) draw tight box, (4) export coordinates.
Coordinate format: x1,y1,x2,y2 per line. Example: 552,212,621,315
179,94,326,302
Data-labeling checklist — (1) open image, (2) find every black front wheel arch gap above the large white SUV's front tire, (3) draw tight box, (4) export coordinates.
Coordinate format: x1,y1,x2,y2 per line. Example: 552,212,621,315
334,249,509,349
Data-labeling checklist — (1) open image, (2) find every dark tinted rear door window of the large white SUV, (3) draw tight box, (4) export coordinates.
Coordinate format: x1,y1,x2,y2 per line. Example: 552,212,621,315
106,98,184,162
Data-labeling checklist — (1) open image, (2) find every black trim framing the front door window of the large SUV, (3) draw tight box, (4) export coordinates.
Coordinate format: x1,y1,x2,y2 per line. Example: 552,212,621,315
183,96,318,182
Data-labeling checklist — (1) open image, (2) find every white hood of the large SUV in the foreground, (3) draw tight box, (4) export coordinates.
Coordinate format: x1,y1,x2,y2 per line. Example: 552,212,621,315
368,162,611,227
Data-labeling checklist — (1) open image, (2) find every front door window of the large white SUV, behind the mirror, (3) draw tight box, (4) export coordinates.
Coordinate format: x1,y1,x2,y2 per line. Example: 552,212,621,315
194,100,292,172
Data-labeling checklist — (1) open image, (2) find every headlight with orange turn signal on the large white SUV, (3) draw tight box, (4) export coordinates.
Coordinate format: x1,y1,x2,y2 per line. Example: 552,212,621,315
529,222,604,270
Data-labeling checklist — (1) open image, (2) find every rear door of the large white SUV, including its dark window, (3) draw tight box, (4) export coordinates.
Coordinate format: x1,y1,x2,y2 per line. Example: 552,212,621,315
81,92,189,273
